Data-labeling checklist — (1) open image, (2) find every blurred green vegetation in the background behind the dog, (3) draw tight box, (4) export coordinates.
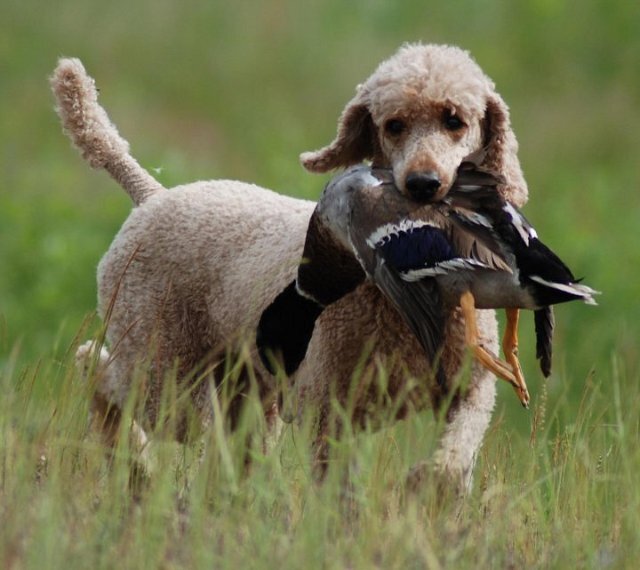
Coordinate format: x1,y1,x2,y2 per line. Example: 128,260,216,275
0,0,640,429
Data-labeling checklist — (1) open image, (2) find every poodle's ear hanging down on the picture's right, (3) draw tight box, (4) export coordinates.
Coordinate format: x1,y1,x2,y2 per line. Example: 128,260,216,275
482,93,529,206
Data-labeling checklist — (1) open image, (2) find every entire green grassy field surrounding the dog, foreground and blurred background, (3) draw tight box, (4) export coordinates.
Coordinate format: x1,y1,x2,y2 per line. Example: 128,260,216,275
0,0,640,568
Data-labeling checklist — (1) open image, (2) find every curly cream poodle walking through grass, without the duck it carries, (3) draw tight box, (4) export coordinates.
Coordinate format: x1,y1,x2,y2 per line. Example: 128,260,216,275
52,45,527,491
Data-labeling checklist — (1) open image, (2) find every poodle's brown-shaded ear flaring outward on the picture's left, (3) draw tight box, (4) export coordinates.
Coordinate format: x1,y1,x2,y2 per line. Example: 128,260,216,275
300,93,377,172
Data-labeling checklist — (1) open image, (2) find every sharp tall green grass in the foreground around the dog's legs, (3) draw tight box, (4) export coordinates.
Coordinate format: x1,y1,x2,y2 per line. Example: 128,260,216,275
0,346,640,568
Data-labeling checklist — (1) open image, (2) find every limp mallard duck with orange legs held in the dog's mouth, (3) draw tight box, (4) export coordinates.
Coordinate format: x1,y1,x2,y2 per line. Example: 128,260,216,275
257,162,597,407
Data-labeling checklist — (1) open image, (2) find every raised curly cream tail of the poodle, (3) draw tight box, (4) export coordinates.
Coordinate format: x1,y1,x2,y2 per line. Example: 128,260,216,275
50,58,165,206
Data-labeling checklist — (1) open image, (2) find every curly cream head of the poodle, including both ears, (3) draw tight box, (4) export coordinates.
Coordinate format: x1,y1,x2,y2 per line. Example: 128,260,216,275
301,44,527,205
